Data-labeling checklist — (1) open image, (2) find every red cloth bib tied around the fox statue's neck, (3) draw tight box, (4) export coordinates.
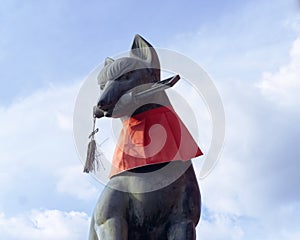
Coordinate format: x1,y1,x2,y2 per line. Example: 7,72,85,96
110,106,203,177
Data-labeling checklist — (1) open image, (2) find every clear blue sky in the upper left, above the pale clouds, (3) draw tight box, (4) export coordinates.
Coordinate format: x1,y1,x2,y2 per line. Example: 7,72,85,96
1,1,253,103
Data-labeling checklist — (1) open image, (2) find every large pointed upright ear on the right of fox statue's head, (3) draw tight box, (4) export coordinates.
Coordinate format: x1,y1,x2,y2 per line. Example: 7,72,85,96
130,34,160,81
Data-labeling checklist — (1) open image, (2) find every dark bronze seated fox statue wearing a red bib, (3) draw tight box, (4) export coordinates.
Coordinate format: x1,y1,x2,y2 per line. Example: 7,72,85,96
89,35,202,240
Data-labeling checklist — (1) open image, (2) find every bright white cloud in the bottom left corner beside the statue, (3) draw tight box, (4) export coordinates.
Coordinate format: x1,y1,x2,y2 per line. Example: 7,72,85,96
0,210,90,240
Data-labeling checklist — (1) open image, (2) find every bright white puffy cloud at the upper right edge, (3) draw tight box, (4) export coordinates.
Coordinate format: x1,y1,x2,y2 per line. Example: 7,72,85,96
257,37,300,108
